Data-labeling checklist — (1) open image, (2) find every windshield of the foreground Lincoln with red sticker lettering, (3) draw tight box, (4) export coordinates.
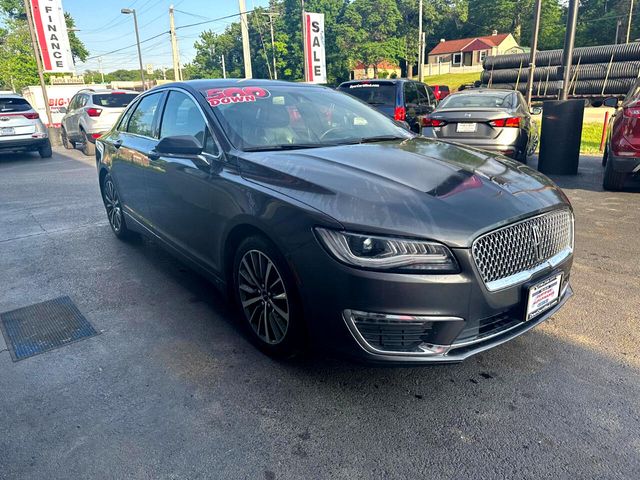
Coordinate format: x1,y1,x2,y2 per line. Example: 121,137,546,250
202,86,413,150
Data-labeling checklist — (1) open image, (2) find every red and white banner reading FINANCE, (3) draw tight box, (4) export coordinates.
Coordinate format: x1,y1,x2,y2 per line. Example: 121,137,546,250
30,0,74,72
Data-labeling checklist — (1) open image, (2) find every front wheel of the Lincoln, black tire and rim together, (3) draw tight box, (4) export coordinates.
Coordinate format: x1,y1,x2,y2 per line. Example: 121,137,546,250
232,236,304,358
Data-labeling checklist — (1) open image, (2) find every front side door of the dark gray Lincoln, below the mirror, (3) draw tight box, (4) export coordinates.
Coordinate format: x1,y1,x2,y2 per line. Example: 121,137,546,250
147,89,225,269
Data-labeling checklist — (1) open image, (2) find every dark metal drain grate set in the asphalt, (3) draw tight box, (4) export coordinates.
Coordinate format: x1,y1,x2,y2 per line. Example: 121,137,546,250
0,297,98,362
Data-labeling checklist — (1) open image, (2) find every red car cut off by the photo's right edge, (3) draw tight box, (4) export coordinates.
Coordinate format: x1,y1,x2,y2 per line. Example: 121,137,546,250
602,78,640,191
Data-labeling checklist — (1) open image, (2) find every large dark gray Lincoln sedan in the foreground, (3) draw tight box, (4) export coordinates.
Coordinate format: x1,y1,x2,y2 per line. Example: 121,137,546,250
96,80,573,363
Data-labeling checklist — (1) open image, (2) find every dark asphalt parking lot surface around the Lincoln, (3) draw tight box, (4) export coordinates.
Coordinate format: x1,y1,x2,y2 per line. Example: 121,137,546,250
0,150,640,480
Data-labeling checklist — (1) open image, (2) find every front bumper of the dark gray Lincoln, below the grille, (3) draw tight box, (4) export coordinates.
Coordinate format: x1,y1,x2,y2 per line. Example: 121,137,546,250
289,240,573,364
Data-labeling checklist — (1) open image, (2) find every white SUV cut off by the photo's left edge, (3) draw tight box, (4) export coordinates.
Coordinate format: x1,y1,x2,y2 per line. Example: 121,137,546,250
0,94,52,158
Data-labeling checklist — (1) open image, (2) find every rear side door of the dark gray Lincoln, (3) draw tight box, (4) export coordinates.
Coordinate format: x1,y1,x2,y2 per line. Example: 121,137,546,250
109,91,165,229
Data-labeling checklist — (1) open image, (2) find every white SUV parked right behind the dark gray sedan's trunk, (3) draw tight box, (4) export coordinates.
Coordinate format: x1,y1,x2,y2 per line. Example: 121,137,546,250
60,89,138,156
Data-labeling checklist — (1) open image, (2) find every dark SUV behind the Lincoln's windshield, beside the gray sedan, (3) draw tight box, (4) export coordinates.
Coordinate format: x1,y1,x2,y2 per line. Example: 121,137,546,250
338,78,438,133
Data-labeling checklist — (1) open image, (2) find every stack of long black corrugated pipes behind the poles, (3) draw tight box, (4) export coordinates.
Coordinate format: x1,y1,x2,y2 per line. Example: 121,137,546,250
480,42,640,100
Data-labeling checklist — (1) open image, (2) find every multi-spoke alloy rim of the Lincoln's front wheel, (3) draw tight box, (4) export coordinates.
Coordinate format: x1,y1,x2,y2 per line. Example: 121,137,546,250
238,250,289,345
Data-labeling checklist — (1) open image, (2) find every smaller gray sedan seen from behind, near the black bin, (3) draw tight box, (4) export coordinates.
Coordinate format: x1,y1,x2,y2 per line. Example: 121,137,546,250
422,88,539,163
